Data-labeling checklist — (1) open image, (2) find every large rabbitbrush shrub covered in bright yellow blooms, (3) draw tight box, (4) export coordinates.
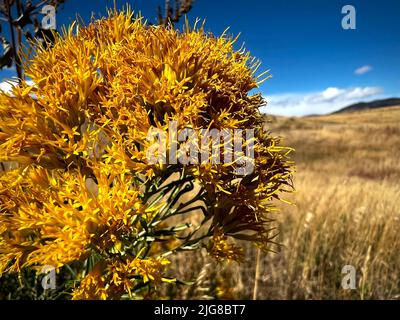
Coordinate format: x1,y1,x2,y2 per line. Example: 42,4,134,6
0,10,291,299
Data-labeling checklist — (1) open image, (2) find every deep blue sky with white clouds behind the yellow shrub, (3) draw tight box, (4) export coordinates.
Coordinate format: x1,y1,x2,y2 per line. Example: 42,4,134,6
0,0,400,115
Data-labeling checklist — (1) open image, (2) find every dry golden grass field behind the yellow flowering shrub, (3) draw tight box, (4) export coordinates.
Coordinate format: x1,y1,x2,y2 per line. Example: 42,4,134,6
170,107,400,299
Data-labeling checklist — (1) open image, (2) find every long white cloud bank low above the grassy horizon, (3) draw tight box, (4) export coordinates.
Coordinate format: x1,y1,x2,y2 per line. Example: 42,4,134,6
261,87,383,116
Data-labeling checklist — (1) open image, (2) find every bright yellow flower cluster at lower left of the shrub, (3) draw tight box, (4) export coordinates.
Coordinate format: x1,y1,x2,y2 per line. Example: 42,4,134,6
0,166,151,271
